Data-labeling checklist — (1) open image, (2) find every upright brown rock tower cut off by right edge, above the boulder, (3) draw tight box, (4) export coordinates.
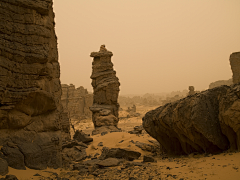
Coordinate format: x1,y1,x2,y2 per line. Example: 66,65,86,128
230,52,240,84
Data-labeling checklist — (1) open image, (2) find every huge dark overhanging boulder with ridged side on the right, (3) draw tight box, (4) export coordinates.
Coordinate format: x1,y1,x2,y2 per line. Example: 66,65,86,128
143,84,240,154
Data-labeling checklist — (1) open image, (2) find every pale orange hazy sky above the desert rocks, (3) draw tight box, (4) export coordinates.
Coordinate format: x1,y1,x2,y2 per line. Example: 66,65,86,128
54,0,240,94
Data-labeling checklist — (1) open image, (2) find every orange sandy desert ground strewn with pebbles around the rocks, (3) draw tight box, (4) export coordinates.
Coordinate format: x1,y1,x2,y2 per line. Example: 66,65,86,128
0,106,240,180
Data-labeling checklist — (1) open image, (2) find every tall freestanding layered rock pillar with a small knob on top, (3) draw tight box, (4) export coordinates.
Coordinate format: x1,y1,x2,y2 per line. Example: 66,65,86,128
90,45,120,133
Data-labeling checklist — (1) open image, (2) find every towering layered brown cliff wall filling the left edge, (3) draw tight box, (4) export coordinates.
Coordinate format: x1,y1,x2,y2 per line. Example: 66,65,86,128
0,0,62,169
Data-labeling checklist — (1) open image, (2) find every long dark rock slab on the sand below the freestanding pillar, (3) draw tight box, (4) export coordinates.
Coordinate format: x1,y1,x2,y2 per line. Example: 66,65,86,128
98,147,141,161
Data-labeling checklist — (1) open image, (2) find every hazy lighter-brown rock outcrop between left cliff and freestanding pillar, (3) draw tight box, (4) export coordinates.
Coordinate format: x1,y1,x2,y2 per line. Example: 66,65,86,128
61,84,93,121
